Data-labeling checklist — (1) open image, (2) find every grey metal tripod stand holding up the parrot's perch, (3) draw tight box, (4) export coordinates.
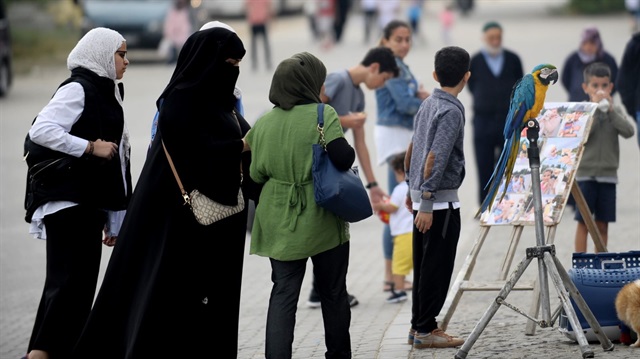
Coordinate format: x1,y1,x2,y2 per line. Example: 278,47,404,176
455,119,614,359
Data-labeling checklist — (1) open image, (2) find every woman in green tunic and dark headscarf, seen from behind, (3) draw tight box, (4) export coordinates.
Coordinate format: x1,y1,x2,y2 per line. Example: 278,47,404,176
245,52,355,359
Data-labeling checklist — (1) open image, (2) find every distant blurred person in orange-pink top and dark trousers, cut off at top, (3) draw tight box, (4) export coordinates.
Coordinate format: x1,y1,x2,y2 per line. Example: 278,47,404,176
244,0,273,71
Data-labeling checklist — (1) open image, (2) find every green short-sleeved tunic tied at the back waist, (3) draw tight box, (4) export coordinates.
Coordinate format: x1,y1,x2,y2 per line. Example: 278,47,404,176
246,104,349,261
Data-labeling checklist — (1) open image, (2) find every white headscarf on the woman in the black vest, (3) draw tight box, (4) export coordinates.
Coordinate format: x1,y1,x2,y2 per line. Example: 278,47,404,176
67,27,126,81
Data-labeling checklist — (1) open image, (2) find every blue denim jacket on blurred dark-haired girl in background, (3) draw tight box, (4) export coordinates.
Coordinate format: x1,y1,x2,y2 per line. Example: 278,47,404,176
376,57,422,130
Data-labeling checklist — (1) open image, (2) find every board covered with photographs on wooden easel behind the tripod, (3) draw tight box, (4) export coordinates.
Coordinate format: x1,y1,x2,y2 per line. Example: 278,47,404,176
480,102,597,225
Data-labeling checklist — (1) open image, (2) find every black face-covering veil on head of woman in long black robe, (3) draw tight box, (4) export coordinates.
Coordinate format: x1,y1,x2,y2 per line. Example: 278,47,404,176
156,27,246,110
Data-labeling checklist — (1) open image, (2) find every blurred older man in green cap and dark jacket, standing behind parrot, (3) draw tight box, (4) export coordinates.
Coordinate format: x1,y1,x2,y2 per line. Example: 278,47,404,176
467,21,524,207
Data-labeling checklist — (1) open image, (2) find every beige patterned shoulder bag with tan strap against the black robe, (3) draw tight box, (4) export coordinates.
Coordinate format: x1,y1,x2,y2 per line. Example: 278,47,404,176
162,142,244,226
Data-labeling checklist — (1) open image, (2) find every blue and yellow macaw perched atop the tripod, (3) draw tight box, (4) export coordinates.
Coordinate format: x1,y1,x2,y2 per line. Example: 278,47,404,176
476,64,558,217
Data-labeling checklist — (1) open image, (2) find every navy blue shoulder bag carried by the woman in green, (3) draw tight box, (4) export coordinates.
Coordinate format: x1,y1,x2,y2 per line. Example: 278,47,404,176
311,103,373,222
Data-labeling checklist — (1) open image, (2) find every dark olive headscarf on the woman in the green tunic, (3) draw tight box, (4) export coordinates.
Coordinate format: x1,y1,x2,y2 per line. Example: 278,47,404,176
269,52,327,110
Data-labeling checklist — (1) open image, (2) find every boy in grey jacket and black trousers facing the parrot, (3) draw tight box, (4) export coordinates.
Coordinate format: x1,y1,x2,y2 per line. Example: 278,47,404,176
405,46,471,349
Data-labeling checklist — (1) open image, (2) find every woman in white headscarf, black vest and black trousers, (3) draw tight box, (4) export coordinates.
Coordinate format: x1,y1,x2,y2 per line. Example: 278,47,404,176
25,28,132,359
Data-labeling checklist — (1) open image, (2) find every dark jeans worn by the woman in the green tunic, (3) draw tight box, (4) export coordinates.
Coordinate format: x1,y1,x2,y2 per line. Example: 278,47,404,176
265,242,351,359
